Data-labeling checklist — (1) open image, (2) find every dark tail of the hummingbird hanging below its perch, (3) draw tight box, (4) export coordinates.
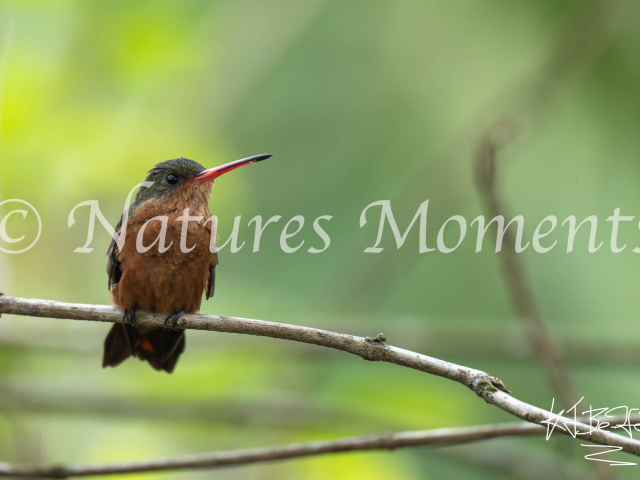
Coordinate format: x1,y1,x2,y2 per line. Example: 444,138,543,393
102,323,185,373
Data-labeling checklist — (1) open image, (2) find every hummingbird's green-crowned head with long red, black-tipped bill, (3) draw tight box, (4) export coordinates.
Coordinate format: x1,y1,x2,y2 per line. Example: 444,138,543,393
133,153,271,212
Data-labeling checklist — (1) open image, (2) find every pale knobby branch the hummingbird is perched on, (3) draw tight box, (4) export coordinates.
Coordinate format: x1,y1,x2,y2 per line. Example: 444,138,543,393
0,296,640,456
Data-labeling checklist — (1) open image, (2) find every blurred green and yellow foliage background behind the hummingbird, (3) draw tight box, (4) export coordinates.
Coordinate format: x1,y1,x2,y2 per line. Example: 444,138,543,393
0,0,640,479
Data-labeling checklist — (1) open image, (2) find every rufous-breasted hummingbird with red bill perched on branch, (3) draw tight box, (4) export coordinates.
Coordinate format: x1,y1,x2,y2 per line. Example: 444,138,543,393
102,154,271,373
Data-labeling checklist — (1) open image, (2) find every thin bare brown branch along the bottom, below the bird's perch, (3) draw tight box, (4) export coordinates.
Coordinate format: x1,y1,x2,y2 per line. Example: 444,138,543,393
0,417,636,478
